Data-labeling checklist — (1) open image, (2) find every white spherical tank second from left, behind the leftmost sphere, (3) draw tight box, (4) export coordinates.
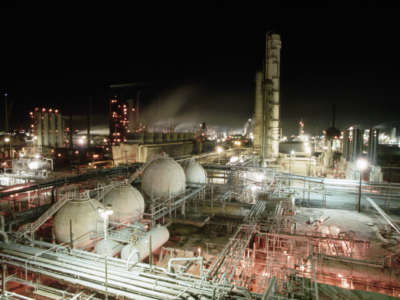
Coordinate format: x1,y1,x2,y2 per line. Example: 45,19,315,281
104,184,144,223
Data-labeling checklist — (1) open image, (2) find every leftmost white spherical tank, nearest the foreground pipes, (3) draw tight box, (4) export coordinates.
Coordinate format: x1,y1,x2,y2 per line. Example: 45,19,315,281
53,199,103,248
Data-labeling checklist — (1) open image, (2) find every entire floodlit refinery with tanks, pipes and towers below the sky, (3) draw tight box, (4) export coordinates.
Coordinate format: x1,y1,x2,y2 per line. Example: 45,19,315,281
0,32,400,300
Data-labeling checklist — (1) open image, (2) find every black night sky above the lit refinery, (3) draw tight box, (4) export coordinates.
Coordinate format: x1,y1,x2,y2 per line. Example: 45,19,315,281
0,1,400,134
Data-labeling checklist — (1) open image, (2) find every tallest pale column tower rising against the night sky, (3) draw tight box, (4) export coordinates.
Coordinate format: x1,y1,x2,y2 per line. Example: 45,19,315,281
265,33,282,158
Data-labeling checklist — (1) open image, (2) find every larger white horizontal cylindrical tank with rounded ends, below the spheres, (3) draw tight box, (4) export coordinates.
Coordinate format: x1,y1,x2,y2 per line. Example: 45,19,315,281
121,226,169,264
